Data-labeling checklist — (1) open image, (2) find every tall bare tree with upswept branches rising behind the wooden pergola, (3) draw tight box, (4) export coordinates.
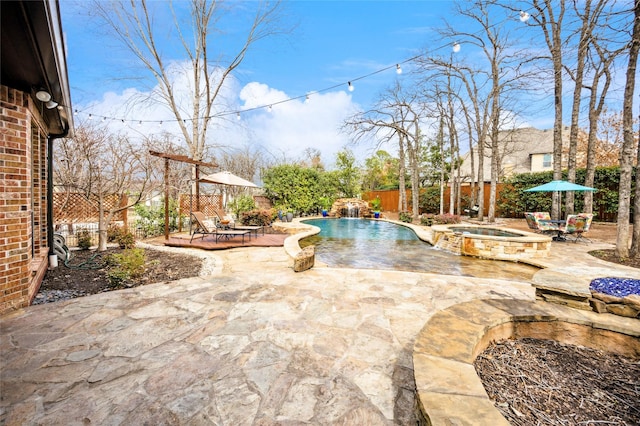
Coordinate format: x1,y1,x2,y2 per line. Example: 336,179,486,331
92,0,280,161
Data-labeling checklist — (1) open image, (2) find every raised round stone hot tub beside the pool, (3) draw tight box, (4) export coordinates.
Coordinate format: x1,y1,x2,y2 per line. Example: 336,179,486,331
431,224,552,262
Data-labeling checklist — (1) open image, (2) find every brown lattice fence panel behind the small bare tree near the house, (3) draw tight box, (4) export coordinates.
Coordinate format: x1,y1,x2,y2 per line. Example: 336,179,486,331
53,192,124,223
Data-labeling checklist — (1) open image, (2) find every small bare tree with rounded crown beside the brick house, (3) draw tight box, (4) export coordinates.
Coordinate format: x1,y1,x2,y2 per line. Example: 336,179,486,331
55,123,161,251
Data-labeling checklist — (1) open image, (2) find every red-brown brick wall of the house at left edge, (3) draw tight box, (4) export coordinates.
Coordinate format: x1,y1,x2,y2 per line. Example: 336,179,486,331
0,85,48,315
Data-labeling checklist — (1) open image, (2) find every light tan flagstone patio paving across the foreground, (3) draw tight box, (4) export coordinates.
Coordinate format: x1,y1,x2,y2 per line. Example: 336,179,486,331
0,231,636,425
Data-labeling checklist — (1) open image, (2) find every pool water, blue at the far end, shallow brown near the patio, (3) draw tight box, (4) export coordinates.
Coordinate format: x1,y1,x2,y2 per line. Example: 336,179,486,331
300,218,539,280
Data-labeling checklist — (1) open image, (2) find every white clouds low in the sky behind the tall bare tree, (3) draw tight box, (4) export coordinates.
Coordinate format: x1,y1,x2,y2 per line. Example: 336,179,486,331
78,64,372,167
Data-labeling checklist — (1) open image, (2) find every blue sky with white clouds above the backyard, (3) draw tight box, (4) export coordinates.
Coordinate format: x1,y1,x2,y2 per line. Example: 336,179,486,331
61,0,632,166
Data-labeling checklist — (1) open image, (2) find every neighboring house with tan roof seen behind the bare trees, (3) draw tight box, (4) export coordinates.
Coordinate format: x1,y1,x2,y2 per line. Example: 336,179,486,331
460,127,569,181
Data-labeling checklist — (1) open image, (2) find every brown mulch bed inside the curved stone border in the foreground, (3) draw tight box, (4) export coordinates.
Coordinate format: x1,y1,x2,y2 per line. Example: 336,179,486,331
475,339,640,426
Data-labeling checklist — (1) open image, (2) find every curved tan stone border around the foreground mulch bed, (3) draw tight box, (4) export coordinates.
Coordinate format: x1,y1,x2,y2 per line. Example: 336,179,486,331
413,299,640,426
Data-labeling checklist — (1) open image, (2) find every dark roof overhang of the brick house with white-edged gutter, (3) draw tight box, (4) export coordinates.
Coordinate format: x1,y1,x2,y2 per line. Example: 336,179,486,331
0,0,73,136
